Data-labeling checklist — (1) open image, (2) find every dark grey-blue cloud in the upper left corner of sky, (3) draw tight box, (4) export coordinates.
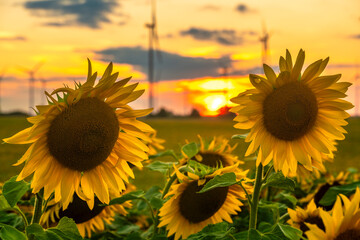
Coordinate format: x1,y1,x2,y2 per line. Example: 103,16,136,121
24,0,118,28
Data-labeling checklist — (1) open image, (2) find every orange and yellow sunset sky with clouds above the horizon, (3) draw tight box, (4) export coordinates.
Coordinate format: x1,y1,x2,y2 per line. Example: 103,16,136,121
0,0,360,115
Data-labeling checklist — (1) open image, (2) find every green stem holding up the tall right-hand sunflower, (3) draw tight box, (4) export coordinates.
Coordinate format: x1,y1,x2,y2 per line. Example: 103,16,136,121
249,163,263,230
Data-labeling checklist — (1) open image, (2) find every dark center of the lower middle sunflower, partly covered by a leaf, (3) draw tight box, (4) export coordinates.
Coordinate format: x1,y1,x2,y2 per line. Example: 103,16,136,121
179,178,229,223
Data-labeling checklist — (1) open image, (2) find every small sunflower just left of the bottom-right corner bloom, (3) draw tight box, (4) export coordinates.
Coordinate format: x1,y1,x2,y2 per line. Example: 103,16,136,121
288,200,325,232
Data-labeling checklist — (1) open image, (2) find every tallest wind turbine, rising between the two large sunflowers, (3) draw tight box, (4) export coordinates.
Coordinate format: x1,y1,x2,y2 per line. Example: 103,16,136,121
145,0,162,108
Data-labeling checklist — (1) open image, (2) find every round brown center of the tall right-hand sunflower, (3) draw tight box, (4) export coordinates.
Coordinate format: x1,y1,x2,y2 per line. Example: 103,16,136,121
263,82,318,141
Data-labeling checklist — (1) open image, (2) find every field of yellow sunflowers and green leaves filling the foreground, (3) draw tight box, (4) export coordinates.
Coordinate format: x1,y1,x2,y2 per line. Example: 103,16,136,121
0,50,360,240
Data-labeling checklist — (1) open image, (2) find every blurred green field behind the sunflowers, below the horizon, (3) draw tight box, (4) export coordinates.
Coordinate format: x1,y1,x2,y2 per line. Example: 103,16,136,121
0,117,360,189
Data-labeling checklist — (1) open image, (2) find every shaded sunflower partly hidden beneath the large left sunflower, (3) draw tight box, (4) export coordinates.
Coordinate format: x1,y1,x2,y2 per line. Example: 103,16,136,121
40,194,132,238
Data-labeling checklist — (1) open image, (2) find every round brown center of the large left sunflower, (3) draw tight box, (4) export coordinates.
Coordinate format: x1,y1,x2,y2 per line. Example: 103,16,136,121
47,98,119,171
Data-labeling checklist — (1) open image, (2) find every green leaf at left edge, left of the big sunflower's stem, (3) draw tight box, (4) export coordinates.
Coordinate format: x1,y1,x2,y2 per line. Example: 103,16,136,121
2,176,30,207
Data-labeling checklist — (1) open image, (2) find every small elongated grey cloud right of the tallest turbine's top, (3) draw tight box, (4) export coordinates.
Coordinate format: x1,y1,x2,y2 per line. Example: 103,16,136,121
180,27,244,46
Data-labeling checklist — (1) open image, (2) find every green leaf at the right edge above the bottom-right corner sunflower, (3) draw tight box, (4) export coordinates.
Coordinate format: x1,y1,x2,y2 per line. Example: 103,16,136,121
319,181,360,206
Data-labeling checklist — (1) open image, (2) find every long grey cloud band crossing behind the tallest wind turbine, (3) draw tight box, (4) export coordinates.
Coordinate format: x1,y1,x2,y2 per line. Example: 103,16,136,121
96,47,231,80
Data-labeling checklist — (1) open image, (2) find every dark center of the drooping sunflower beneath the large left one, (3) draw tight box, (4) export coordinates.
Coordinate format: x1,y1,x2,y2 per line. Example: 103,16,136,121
59,194,105,224
